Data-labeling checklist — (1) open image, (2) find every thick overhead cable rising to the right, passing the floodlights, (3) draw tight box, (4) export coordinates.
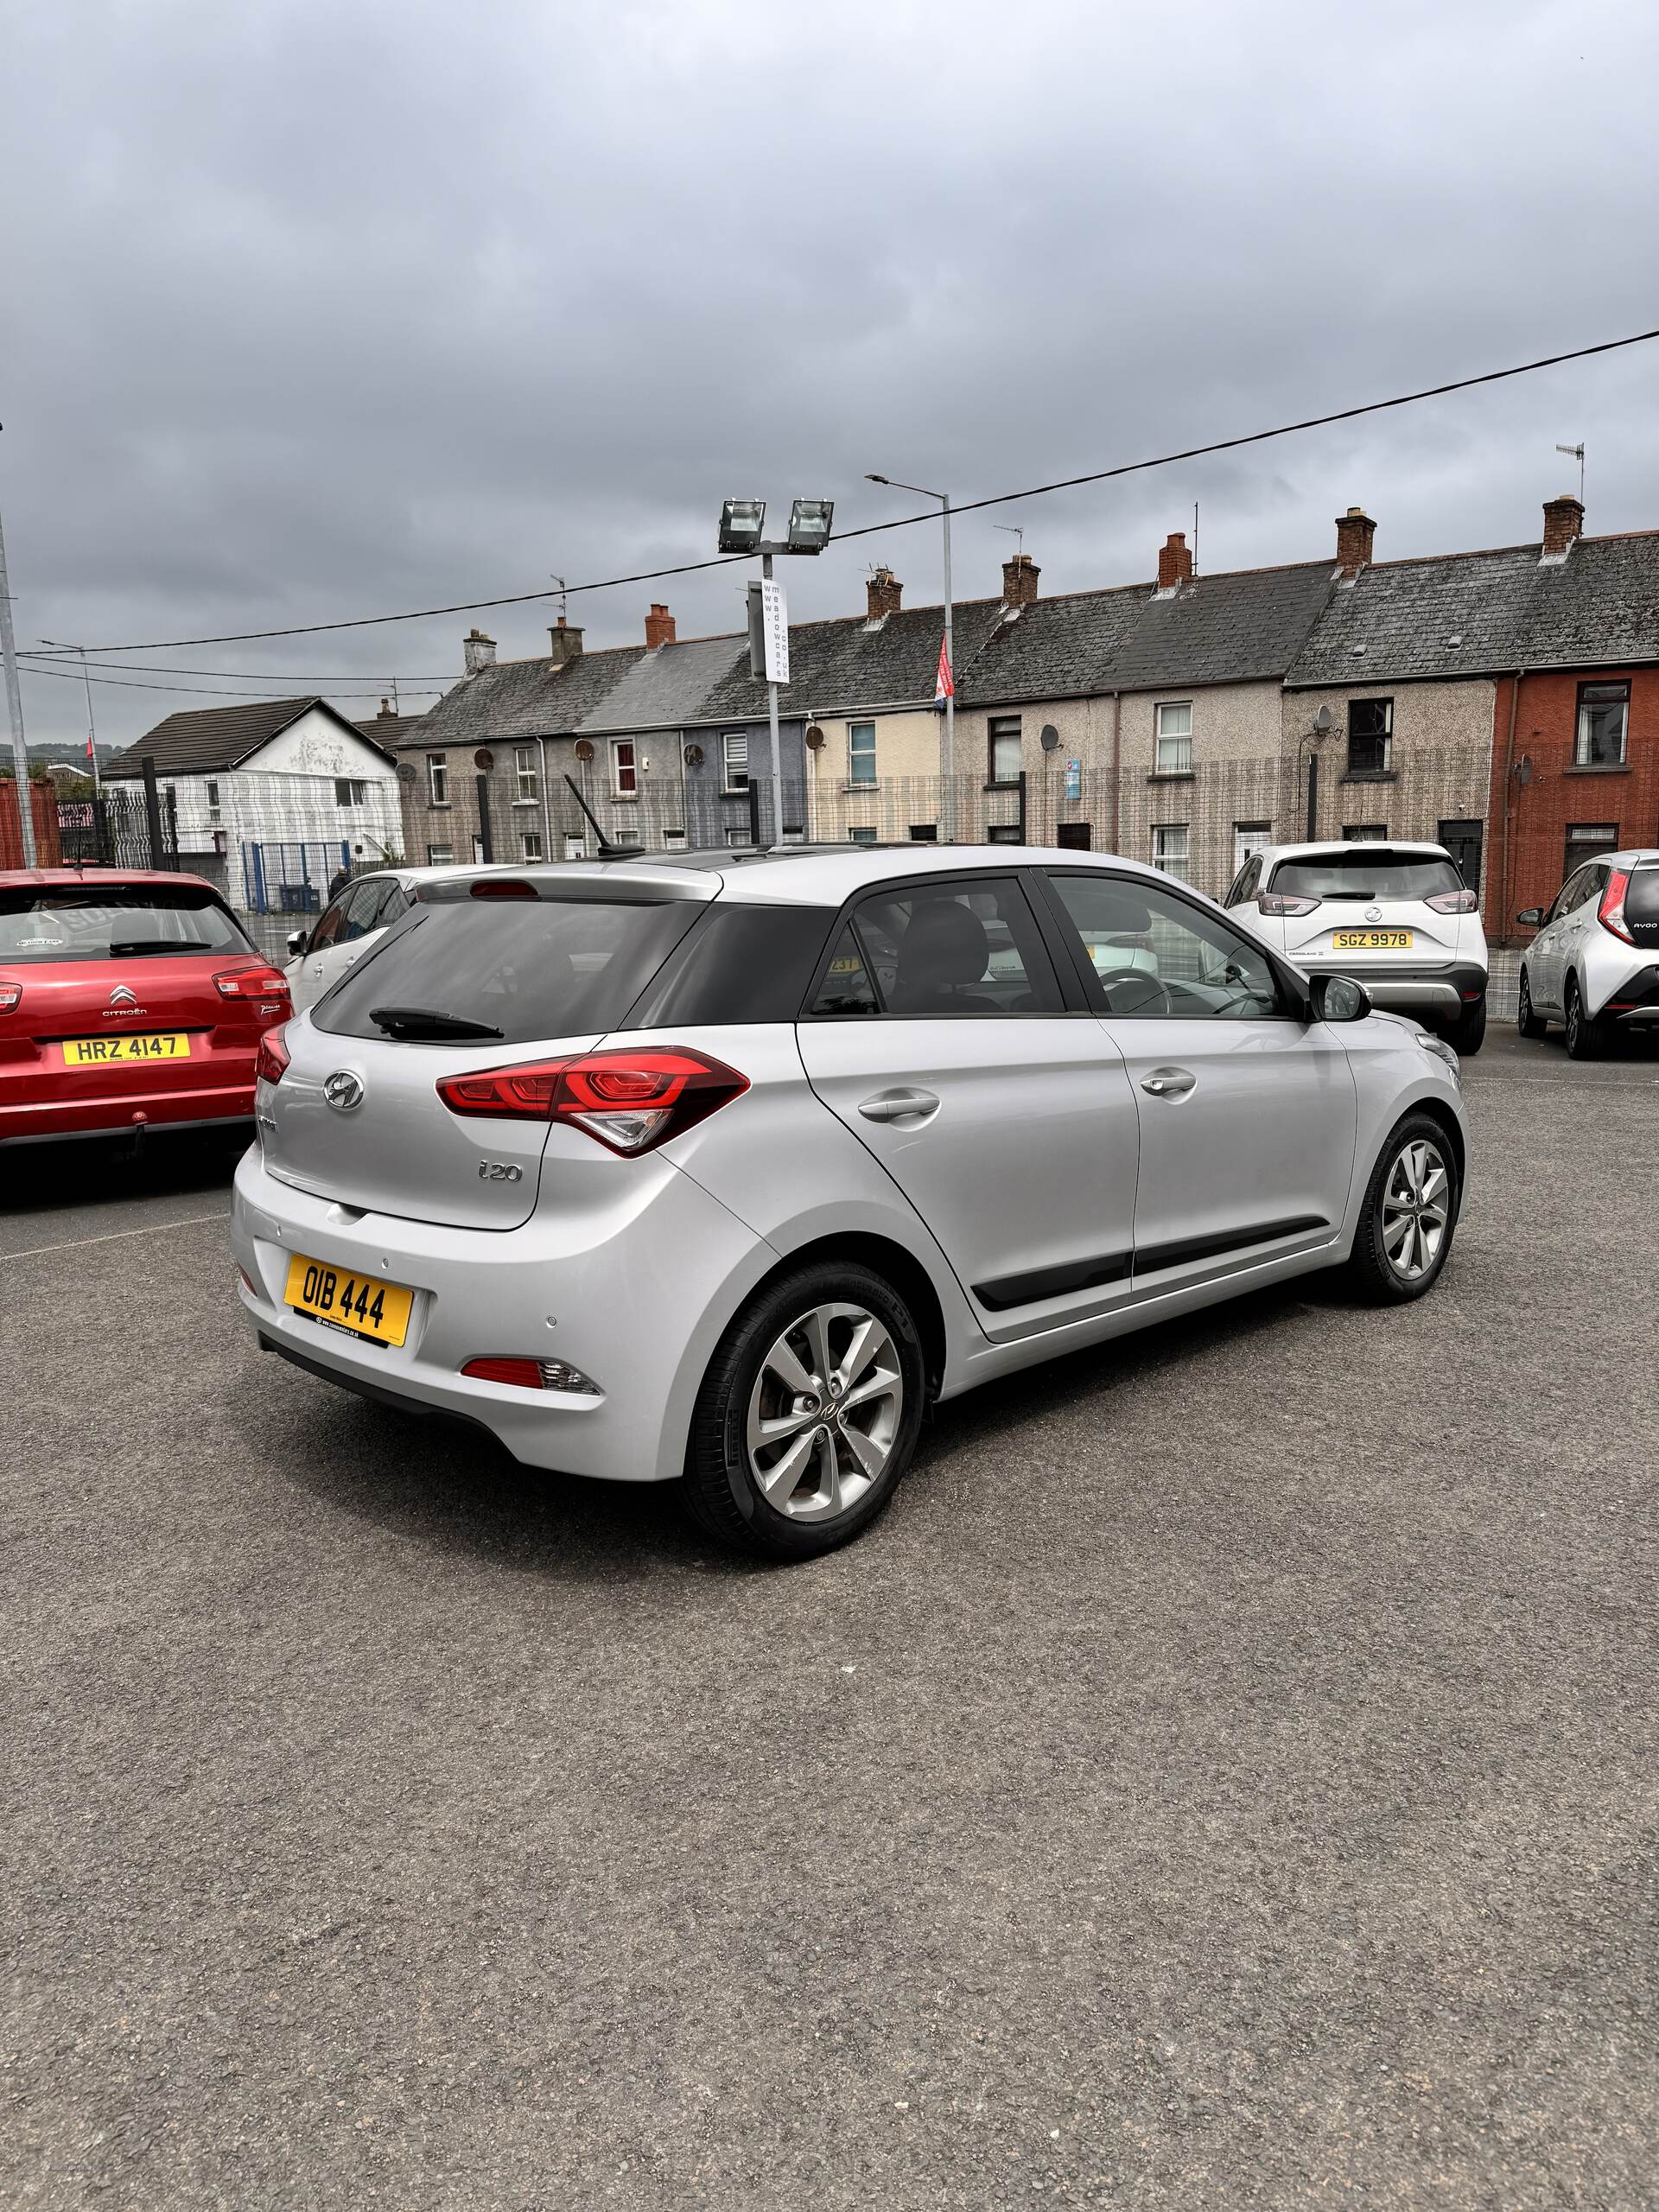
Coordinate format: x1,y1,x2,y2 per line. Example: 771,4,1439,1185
65,329,1659,652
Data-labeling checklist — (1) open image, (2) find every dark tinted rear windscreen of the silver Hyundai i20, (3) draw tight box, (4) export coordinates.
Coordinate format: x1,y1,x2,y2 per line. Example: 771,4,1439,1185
312,898,703,1044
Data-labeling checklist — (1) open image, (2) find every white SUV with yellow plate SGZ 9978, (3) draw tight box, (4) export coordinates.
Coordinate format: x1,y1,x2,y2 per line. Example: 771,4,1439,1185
1224,838,1486,1055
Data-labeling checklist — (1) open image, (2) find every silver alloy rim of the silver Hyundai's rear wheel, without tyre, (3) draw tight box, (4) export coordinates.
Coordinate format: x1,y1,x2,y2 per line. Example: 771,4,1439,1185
747,1303,905,1522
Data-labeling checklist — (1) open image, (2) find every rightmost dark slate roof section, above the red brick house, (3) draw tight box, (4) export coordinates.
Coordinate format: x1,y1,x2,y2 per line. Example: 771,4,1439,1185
1285,531,1659,688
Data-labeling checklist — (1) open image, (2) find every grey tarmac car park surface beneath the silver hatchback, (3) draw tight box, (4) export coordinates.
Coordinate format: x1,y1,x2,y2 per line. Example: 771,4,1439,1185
0,1038,1659,2212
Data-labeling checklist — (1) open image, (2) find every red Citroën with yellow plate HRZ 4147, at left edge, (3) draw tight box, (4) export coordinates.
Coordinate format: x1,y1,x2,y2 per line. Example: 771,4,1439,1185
0,868,289,1150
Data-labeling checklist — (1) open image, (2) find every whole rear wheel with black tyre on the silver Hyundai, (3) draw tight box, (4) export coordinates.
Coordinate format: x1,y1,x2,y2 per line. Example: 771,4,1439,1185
681,1261,927,1560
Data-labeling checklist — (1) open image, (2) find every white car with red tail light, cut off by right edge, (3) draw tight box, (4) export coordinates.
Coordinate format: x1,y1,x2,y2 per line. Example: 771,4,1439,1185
1516,845,1659,1059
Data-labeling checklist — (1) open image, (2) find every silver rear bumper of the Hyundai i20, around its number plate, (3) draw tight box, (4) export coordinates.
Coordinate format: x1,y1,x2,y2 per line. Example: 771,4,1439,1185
230,1148,777,1482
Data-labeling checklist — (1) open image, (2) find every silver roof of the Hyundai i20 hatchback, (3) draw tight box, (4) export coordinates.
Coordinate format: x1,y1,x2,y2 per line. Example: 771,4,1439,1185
422,842,1190,907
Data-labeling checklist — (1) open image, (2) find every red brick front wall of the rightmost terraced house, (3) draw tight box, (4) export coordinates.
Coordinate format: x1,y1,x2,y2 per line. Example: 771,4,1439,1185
1486,668,1659,943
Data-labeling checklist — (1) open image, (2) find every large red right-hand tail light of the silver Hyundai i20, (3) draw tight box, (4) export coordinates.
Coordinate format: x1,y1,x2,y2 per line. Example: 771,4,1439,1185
438,1046,750,1157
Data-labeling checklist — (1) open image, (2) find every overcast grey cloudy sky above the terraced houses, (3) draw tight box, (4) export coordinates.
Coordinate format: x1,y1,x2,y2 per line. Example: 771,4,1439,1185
0,0,1659,743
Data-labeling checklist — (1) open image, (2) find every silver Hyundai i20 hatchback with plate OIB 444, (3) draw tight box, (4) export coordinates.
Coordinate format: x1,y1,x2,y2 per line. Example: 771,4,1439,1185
232,845,1466,1557
